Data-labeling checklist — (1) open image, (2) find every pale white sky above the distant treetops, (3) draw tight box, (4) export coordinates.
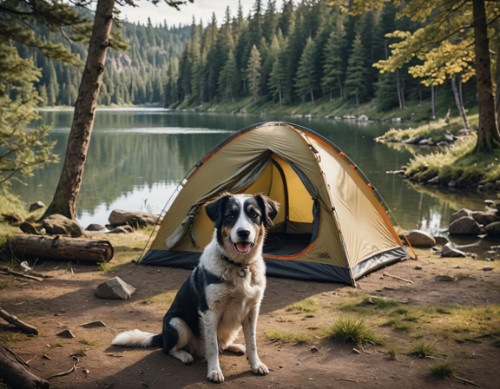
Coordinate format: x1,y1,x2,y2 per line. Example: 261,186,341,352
120,0,254,26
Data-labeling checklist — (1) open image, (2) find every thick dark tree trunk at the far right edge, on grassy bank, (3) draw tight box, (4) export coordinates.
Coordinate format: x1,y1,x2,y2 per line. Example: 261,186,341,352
472,0,500,152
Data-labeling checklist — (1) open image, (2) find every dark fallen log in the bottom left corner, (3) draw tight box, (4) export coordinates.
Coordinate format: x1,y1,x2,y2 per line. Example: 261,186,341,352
0,347,49,389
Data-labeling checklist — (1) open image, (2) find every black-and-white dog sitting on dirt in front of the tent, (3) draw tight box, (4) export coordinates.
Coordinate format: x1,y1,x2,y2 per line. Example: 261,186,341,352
111,193,279,382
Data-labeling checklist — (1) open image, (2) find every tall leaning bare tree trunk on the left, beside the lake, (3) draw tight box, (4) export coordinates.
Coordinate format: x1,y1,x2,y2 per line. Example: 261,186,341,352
42,0,115,219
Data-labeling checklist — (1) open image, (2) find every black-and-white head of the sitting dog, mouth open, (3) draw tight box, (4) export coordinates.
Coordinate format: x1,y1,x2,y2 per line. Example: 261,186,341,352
205,193,279,254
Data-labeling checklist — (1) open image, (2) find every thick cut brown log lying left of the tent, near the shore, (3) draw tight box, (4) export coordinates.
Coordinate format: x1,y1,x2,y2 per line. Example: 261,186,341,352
10,234,114,263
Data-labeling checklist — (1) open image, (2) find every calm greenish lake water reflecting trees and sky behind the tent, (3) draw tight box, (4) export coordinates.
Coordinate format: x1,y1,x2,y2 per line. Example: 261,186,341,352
12,108,485,233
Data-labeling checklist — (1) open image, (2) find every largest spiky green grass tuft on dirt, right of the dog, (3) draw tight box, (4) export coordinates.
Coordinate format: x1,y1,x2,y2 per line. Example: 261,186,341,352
325,316,384,345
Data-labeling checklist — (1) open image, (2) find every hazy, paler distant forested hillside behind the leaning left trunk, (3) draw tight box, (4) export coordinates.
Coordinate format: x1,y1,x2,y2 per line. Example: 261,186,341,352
18,18,190,106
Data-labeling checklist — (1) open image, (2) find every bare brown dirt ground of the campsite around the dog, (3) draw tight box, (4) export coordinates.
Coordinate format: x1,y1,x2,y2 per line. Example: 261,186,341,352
0,241,500,388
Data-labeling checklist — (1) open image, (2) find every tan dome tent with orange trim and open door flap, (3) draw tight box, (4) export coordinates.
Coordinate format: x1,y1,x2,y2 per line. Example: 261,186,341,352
141,122,406,285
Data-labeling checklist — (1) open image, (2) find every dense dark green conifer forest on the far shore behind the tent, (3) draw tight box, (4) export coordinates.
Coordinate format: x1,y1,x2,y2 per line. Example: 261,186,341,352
166,0,476,114
